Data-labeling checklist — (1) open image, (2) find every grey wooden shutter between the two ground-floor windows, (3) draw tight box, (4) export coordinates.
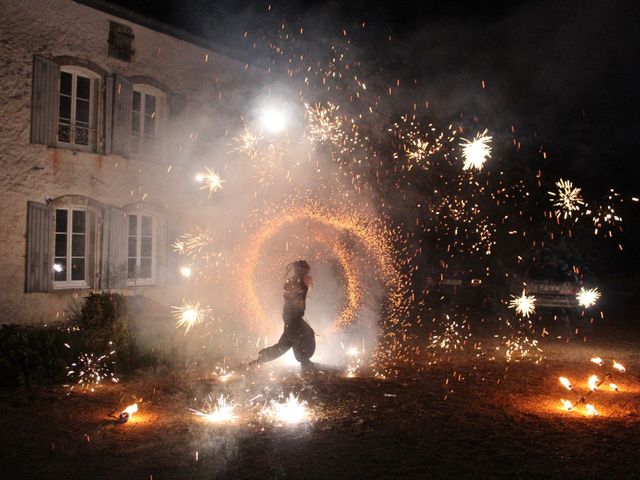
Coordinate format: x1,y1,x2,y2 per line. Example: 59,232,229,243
100,208,128,290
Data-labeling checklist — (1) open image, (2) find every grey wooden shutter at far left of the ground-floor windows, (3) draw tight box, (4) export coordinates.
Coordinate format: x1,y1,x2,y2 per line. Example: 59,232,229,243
25,202,53,293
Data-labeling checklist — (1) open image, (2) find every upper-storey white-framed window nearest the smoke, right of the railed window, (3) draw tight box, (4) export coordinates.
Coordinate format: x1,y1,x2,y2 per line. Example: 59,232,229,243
131,85,164,155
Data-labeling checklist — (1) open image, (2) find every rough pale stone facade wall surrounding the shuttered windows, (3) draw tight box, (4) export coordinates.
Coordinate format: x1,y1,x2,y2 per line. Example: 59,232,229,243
0,0,262,323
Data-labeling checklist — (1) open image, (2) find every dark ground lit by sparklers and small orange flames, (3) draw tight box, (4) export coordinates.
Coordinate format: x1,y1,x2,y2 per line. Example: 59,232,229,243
0,316,640,480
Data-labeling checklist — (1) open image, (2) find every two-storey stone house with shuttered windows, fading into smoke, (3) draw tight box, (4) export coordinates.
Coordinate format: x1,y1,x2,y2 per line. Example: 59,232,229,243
0,0,264,323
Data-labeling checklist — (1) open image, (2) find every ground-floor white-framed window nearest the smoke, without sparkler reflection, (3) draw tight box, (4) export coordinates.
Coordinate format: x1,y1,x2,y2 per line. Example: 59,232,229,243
127,214,157,284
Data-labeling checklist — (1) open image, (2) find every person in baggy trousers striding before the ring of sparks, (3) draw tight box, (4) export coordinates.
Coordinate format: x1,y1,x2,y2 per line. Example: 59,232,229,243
249,260,316,368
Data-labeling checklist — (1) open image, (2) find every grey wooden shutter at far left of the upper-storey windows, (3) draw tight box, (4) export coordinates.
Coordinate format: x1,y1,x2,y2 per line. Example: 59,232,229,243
31,55,60,145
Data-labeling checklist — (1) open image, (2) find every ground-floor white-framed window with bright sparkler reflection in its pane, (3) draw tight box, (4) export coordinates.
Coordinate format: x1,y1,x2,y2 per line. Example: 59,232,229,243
53,208,89,288
